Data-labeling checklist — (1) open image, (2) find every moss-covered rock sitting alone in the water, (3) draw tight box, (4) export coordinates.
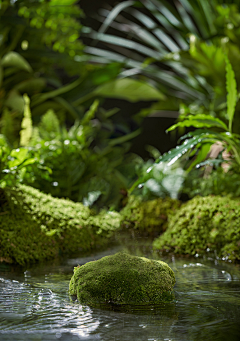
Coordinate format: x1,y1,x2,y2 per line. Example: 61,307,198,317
69,252,175,306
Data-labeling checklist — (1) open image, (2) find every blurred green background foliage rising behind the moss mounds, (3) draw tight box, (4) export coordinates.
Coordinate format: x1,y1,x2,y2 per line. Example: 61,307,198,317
0,0,240,209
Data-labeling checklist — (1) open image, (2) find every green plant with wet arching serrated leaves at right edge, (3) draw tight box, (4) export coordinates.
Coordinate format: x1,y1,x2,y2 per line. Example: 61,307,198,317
129,56,240,194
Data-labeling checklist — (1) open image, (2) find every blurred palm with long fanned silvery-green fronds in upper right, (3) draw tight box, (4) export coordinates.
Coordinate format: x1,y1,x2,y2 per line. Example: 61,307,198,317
85,0,240,120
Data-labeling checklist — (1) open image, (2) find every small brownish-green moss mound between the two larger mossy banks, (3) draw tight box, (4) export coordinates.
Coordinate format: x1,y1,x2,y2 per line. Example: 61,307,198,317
121,196,180,236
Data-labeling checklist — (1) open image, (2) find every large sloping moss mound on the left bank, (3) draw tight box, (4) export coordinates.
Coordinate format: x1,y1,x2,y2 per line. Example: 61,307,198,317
0,185,120,264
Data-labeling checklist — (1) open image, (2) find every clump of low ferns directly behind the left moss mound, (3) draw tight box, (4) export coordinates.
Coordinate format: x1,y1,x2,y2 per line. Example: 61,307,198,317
21,105,140,209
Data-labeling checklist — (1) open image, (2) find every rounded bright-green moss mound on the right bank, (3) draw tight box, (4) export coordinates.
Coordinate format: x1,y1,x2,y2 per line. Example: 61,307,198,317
153,196,240,260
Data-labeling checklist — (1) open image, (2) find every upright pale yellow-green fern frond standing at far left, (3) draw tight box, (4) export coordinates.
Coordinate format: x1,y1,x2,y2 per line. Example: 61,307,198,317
20,94,33,146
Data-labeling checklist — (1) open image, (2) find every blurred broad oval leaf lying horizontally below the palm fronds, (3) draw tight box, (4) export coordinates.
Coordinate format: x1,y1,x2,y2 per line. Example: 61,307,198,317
94,78,165,102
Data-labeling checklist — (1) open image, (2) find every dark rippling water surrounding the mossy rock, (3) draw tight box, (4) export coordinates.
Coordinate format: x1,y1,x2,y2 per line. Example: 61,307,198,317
0,242,240,341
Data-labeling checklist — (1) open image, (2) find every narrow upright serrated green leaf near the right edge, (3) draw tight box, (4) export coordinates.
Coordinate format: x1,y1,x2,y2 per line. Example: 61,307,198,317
226,56,237,132
